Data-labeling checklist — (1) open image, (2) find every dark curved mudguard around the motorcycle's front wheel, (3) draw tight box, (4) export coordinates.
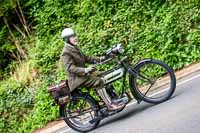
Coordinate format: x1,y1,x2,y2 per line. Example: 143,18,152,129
129,59,152,103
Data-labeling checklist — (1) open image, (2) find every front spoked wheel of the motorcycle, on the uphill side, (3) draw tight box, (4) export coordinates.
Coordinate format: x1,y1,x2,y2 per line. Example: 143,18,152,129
130,60,176,104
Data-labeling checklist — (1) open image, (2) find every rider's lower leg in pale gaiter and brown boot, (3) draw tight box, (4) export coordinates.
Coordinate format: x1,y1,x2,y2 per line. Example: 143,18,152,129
97,88,124,111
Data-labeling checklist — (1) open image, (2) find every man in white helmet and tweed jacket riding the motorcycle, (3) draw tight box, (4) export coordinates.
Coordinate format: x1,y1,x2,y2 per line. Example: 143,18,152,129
61,28,124,111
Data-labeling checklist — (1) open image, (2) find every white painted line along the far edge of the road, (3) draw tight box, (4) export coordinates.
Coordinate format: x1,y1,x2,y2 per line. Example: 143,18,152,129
59,74,200,133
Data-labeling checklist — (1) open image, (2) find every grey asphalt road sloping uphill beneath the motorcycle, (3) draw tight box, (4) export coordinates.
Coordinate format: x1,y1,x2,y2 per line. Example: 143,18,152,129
54,72,200,133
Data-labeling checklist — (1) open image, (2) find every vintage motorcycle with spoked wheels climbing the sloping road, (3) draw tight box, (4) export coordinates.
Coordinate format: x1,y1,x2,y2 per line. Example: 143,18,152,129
48,44,176,132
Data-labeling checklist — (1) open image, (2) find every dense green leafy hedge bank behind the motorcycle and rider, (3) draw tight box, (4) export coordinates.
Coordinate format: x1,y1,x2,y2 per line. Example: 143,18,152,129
0,0,200,133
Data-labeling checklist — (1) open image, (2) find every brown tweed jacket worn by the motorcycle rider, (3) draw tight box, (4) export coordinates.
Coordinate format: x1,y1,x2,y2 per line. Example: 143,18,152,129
61,43,101,91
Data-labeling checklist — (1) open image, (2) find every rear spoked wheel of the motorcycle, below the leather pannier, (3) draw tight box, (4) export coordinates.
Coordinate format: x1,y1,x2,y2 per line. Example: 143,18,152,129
64,96,100,132
